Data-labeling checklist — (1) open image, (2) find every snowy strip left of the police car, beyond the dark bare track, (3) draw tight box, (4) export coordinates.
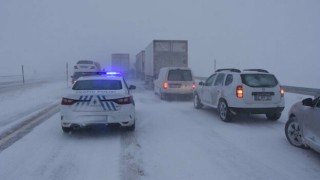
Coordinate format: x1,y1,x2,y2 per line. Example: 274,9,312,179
0,81,67,134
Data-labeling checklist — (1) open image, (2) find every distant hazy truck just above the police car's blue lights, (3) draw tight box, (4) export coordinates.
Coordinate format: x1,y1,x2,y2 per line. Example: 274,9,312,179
111,53,130,76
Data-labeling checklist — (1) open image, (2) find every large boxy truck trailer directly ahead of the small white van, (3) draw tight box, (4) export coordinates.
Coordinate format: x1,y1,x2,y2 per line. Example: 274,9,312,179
144,40,188,87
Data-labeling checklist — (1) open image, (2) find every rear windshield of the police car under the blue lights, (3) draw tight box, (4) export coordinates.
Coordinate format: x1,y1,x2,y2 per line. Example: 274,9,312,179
72,80,122,90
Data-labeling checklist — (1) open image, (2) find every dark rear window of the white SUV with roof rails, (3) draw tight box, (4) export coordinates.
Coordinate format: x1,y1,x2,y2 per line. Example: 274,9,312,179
241,74,278,87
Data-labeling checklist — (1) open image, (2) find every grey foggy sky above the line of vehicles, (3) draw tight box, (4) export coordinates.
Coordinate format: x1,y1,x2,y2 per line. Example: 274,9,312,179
0,0,320,88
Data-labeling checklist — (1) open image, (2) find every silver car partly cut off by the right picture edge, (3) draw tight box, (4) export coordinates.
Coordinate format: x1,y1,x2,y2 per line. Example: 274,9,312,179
285,96,320,152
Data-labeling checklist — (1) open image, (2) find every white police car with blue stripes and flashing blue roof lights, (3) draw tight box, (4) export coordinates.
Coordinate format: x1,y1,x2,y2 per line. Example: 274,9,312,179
60,72,136,132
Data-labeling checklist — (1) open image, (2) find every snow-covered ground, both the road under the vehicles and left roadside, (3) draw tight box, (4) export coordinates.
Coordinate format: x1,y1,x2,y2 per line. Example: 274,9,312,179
0,79,320,180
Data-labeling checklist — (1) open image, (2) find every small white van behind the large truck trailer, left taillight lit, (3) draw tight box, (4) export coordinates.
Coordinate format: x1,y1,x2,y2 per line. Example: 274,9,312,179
154,67,195,99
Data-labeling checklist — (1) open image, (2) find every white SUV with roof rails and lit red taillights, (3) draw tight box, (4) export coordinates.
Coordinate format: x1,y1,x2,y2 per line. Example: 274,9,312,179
194,69,284,121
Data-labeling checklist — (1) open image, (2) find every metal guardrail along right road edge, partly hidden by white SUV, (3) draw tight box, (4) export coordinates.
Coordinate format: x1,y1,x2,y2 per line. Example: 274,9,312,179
195,76,320,96
